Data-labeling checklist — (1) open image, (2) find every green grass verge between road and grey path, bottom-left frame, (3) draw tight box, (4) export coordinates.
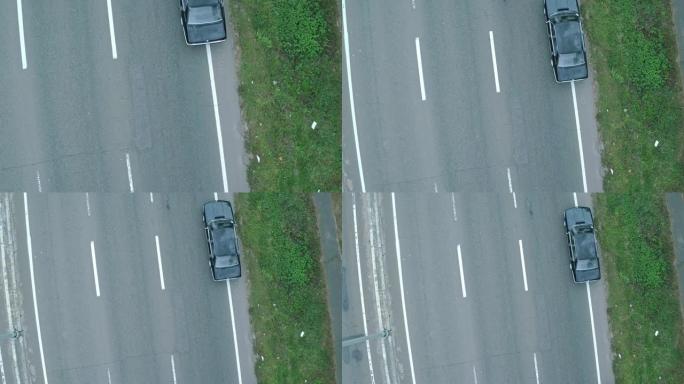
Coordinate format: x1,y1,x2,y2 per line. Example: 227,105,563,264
236,192,335,384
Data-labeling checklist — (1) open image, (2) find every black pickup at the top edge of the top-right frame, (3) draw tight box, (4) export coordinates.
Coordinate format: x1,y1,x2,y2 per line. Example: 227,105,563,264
544,0,589,83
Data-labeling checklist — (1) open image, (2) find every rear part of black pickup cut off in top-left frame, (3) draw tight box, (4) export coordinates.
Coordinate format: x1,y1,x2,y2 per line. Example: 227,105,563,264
180,0,226,45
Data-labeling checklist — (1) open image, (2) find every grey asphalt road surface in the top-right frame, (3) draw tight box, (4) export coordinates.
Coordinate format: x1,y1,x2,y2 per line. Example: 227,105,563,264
343,1,602,192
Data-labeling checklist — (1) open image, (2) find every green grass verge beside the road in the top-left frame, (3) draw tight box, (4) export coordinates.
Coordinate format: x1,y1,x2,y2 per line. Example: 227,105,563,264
230,0,342,192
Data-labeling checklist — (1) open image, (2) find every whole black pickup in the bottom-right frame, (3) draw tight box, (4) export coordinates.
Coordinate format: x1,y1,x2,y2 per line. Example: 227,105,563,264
564,207,601,283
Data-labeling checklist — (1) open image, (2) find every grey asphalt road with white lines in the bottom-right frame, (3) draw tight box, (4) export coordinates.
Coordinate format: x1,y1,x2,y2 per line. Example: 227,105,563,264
343,193,614,383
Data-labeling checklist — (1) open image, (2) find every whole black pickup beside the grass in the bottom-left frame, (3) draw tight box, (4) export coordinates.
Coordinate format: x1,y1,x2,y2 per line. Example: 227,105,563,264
202,200,241,281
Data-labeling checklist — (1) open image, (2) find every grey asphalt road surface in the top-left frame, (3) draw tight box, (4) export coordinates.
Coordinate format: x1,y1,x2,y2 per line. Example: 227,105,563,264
0,0,248,192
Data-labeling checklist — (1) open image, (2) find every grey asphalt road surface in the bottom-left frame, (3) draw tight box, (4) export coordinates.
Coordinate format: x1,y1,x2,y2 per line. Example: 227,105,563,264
3,193,256,383
